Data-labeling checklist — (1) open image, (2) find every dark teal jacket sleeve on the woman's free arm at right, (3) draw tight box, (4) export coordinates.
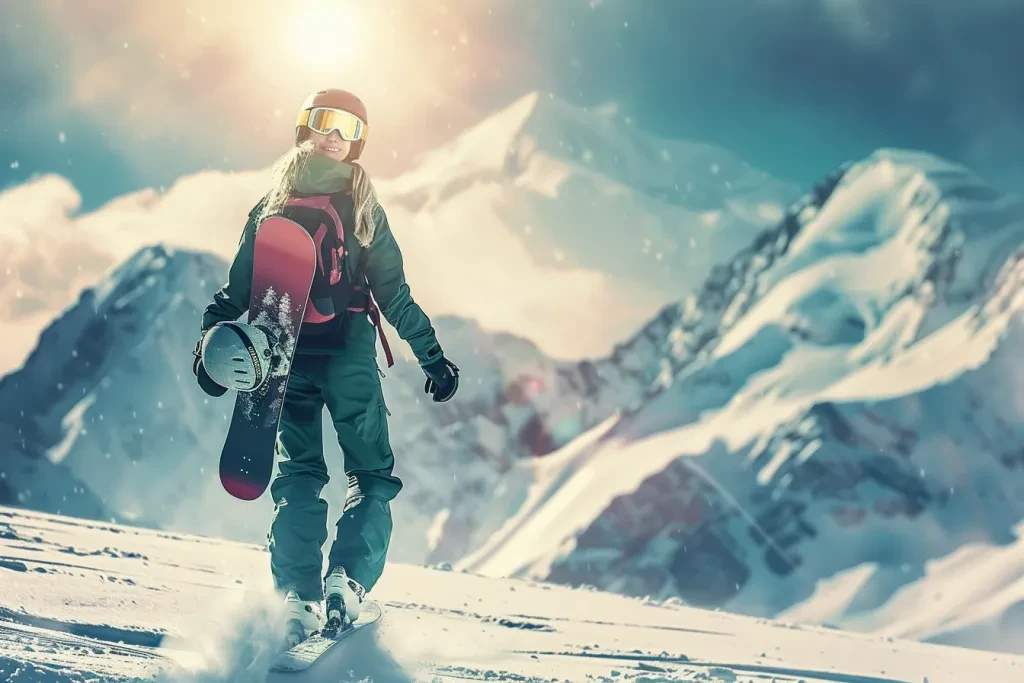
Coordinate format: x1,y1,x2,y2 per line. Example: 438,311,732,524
365,205,442,366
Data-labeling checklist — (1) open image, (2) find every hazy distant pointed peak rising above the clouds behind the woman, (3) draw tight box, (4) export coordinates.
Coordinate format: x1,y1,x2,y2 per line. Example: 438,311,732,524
386,92,794,219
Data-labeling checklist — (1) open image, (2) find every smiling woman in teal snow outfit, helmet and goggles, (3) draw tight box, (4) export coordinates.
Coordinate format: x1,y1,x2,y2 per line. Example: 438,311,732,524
193,89,459,643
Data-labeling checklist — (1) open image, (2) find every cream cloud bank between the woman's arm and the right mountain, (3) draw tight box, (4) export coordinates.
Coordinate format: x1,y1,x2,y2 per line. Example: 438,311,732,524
387,193,666,358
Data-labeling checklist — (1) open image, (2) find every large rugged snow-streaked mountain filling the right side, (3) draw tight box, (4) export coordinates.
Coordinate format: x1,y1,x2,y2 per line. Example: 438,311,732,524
459,151,1024,643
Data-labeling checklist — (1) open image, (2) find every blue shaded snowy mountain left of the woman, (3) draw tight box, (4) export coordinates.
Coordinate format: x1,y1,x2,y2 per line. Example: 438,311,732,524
0,246,224,524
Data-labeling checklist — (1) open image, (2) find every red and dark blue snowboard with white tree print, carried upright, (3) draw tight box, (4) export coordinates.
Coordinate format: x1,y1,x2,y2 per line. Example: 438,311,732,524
220,216,316,501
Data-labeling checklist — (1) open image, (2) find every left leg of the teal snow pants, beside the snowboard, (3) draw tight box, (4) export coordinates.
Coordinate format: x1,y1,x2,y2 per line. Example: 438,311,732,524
269,356,329,600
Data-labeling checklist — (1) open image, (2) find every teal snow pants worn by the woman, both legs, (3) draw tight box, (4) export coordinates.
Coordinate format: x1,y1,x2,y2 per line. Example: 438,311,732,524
269,350,402,600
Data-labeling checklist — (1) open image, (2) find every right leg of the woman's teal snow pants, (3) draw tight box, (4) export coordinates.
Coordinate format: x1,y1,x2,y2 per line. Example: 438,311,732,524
323,356,402,591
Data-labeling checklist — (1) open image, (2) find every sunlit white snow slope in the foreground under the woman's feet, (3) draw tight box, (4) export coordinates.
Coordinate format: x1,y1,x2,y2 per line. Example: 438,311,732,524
0,508,1024,683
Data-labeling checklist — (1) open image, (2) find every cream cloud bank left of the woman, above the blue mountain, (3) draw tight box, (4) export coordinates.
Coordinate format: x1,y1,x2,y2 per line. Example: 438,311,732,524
0,167,268,374
